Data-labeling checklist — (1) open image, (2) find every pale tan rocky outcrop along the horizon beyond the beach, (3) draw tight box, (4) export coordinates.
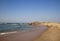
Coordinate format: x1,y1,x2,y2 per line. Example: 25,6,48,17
29,22,60,27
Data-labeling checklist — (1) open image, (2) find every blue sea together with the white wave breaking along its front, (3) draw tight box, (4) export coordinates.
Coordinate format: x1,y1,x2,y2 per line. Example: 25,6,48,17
0,23,34,35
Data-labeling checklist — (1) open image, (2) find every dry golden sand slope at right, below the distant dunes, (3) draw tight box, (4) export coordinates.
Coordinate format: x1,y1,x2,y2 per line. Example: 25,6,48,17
34,27,60,41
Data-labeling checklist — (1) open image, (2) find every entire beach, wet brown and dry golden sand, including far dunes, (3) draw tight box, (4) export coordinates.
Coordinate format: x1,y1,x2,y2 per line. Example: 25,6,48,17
0,23,60,41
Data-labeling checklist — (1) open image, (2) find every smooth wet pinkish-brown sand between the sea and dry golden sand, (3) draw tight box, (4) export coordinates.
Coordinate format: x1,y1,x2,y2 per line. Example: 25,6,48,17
0,27,48,41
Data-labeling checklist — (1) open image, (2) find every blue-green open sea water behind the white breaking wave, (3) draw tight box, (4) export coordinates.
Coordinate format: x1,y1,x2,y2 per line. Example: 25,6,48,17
0,24,33,33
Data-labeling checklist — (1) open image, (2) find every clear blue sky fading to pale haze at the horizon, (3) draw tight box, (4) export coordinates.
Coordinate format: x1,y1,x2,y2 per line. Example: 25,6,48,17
0,0,60,22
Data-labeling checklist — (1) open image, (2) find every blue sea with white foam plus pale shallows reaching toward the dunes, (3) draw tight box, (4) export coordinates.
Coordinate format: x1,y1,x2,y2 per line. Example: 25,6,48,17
0,24,47,35
